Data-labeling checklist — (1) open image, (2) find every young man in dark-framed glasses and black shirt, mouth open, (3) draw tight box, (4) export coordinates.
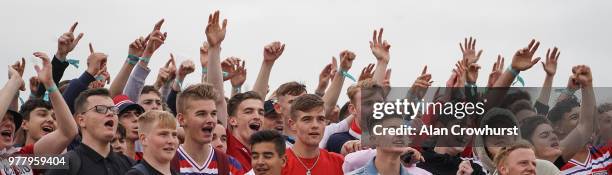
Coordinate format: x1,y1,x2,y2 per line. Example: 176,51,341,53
46,88,134,174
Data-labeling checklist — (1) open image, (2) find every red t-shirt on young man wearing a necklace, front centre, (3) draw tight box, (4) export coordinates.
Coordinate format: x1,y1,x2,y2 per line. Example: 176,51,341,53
281,148,344,175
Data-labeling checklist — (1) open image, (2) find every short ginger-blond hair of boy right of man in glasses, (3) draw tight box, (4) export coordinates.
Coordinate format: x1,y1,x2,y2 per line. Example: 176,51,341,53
138,110,176,134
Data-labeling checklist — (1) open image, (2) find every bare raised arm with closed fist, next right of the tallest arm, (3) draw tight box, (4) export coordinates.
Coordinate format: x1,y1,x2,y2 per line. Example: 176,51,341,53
253,41,285,97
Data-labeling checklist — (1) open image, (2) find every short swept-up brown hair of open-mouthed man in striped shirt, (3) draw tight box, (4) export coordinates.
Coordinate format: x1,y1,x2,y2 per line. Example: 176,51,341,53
176,83,217,113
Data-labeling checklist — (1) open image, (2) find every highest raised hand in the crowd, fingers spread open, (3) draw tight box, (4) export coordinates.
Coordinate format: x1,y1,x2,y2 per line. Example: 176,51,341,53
205,10,227,48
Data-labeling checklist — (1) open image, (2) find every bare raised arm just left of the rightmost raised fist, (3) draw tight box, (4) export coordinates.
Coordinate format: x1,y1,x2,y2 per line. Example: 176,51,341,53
536,47,561,114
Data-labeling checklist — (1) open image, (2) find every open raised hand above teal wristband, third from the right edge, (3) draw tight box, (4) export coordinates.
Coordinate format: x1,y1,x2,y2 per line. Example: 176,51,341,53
512,39,540,71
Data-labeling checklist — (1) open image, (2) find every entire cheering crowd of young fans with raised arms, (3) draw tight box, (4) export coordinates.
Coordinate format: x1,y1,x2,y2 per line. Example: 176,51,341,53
0,11,612,175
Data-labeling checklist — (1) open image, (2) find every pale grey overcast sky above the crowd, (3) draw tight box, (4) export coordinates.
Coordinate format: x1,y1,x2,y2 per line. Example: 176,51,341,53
0,0,612,103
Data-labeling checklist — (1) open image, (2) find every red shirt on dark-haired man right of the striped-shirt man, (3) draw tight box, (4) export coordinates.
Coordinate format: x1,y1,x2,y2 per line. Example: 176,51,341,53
225,129,251,172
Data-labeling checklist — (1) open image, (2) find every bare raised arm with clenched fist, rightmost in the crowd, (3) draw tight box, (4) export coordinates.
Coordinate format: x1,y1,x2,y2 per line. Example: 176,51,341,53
560,65,596,160
